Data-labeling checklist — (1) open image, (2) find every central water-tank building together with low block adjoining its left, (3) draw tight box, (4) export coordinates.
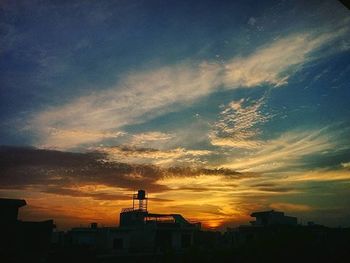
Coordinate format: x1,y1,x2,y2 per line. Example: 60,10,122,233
68,190,200,253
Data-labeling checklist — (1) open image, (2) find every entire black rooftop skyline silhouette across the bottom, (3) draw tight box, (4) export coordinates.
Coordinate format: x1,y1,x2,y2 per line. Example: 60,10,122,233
0,197,350,263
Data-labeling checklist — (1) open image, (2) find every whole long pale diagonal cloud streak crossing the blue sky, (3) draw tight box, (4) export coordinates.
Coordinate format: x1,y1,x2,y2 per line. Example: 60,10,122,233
28,27,347,149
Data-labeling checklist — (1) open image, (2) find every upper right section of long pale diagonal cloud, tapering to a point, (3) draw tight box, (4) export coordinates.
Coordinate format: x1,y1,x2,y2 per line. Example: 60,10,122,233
223,27,347,88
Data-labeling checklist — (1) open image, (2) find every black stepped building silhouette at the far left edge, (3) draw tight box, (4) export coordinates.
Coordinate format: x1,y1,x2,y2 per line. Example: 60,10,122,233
0,198,54,262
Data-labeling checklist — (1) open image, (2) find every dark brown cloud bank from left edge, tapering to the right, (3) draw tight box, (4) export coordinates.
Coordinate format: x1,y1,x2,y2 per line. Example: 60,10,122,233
0,146,249,194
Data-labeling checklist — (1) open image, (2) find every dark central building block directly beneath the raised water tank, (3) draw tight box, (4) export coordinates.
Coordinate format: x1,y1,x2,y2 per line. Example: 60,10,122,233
117,190,200,253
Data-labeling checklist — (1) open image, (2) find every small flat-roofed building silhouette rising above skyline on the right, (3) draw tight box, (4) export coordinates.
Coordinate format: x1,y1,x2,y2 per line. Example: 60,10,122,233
250,210,298,226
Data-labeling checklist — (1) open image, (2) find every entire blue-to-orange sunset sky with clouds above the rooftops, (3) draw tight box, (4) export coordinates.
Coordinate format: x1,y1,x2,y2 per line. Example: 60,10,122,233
0,0,350,229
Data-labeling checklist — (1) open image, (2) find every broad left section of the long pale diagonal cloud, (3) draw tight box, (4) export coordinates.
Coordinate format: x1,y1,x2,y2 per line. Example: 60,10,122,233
29,62,220,150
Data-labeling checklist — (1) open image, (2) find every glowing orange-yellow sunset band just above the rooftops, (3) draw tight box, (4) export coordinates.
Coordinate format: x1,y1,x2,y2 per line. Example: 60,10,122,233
1,168,348,229
